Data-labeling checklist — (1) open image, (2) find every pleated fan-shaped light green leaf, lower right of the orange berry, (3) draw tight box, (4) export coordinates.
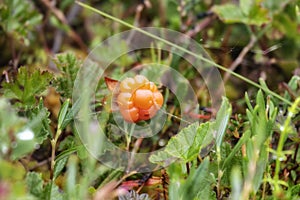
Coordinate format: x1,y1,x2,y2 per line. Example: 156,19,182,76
165,123,210,162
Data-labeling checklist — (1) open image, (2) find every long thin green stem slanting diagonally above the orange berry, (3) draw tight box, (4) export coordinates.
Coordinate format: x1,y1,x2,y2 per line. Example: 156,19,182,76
76,1,299,109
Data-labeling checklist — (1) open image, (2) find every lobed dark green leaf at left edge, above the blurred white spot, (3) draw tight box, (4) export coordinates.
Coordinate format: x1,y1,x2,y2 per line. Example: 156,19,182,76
3,67,52,107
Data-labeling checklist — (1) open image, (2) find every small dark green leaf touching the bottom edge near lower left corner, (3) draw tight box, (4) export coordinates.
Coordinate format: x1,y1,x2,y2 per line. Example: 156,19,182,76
26,172,44,198
